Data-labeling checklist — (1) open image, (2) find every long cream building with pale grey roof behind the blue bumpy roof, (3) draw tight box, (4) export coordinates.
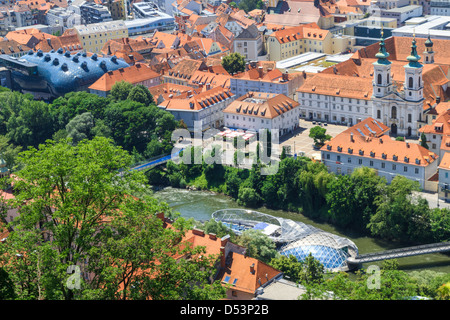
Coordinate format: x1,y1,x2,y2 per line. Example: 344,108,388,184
74,21,128,53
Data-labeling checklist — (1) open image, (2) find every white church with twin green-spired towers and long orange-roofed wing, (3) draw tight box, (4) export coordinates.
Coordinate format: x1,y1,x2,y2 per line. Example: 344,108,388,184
297,37,446,137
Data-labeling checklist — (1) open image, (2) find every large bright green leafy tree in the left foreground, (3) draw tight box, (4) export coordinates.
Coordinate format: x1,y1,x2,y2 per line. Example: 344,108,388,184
0,137,224,300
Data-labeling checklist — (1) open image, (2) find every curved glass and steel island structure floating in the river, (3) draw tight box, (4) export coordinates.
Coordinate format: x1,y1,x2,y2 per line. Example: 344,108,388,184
212,209,358,272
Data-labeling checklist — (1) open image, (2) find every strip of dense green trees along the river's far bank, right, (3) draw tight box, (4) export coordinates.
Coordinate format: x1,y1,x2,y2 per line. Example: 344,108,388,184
146,148,450,243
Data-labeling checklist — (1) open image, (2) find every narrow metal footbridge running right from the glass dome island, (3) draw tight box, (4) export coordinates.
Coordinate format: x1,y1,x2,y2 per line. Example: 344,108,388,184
347,242,450,265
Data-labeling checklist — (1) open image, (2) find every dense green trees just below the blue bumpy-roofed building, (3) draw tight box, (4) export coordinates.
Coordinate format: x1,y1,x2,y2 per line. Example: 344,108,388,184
0,82,179,168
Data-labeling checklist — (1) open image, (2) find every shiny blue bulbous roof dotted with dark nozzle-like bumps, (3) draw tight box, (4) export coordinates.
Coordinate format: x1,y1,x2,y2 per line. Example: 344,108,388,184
22,48,129,95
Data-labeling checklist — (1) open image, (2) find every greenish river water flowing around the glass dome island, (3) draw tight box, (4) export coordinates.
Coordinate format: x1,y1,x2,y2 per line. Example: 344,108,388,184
154,187,450,273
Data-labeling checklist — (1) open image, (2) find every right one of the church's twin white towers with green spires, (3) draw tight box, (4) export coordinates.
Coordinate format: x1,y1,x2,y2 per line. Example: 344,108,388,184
403,37,423,101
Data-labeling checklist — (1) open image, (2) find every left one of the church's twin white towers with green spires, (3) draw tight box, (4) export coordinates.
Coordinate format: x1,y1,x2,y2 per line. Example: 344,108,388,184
372,30,392,98
